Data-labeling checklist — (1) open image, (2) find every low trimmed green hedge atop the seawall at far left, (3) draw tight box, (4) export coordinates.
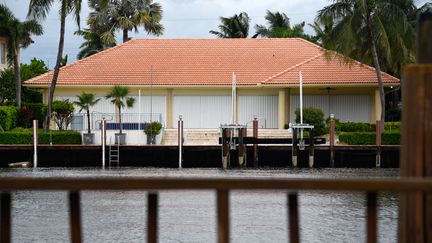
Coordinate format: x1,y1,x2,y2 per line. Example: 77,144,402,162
0,130,81,144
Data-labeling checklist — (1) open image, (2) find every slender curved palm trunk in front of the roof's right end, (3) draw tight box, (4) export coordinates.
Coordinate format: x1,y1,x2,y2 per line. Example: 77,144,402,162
367,14,385,133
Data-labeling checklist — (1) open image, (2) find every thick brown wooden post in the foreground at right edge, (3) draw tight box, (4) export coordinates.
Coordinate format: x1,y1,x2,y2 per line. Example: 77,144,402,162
399,12,432,243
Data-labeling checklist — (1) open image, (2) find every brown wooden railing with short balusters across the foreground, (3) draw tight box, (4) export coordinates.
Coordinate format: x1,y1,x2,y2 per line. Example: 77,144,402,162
0,177,432,243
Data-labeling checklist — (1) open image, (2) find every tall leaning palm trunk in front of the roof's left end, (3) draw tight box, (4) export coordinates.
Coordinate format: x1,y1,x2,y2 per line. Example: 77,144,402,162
44,0,67,132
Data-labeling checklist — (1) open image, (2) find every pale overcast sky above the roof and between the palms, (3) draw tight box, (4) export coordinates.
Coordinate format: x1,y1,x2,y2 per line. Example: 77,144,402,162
0,0,430,65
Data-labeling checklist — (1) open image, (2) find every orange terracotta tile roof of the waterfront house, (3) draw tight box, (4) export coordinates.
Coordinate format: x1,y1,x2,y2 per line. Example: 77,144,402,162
26,38,399,85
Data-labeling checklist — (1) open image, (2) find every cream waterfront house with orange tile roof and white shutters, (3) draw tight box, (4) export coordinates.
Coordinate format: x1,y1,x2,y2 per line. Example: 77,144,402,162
26,38,399,128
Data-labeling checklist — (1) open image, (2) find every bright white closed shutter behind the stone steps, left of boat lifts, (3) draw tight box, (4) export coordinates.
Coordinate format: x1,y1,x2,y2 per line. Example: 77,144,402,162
173,95,231,128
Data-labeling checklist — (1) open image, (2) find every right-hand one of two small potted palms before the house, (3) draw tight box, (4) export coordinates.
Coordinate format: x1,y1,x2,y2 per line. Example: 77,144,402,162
105,85,135,144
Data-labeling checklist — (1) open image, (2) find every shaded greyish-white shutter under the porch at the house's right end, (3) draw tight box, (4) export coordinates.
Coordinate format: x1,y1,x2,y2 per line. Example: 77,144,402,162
290,95,371,123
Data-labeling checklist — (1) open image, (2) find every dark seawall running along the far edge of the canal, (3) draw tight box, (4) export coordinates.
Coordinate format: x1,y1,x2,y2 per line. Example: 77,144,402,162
0,145,400,168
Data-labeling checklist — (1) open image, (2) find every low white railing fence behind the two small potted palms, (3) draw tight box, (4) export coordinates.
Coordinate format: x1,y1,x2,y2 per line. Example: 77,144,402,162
70,112,164,131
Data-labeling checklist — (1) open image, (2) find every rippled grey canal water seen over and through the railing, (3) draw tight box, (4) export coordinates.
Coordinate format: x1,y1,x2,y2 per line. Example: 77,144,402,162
0,168,399,243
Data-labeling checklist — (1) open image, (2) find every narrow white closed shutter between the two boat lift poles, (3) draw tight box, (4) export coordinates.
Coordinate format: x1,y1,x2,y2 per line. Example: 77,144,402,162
238,95,278,128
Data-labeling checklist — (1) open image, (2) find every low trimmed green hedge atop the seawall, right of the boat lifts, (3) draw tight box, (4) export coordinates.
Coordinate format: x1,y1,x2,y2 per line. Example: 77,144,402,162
339,132,400,145
